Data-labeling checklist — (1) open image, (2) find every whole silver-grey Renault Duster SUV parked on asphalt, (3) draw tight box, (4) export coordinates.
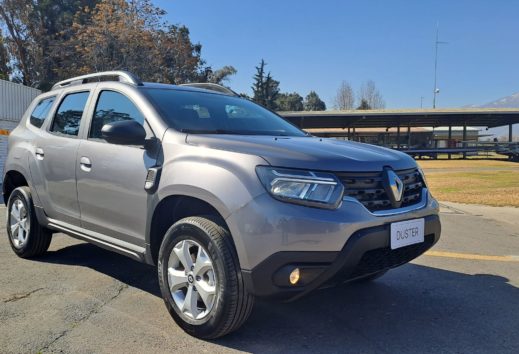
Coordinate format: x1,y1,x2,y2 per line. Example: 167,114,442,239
3,71,440,338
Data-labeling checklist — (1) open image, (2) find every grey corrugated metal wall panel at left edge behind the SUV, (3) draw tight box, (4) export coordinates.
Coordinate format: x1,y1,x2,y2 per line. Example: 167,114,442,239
0,80,41,121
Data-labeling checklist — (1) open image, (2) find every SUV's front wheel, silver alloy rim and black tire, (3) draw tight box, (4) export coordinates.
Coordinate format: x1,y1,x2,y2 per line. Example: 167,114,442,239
157,217,254,339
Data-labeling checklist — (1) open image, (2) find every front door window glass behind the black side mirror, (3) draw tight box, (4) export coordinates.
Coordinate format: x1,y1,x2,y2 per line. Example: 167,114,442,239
88,91,144,139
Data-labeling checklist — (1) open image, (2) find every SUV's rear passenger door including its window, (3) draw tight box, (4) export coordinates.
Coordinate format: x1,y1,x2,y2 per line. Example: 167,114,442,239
29,90,90,226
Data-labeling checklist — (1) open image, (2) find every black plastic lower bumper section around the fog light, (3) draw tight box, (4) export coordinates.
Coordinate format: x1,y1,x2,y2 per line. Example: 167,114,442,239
242,214,441,300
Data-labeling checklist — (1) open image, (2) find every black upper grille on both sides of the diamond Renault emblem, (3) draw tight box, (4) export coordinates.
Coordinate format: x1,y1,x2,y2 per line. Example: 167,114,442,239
336,168,424,211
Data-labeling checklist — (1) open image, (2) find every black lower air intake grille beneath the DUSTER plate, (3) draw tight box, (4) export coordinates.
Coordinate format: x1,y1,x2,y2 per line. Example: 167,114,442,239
344,235,434,280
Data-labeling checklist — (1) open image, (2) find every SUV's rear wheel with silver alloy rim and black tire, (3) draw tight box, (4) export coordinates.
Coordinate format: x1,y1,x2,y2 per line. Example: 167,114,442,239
6,187,52,258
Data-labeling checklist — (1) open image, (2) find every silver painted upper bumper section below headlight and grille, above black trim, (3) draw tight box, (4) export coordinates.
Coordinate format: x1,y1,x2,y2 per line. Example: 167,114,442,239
226,188,439,271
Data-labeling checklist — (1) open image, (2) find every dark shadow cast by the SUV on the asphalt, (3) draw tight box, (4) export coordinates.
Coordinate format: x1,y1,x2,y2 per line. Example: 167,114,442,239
39,243,519,353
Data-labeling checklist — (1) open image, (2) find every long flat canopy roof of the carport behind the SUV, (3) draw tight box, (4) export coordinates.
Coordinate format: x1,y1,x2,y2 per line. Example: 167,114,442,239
278,108,519,129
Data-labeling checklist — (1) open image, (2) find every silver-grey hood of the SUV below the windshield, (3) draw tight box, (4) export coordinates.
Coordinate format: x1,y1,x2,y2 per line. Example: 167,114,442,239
186,134,416,172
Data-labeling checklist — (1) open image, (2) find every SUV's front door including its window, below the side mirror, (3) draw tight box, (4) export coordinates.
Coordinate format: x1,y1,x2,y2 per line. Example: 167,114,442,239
76,89,156,247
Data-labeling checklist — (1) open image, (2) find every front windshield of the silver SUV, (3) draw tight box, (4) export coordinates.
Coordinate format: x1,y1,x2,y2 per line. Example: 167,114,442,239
144,88,307,136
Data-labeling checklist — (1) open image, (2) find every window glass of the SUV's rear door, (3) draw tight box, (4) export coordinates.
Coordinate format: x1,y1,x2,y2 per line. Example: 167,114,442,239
50,92,90,136
